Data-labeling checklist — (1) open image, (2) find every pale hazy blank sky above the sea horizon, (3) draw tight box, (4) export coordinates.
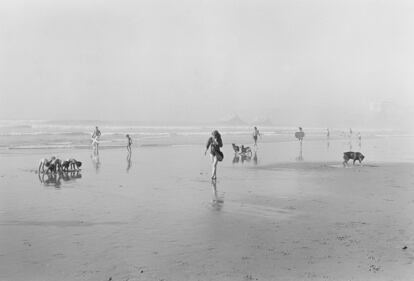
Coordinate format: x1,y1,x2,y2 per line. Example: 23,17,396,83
0,0,414,126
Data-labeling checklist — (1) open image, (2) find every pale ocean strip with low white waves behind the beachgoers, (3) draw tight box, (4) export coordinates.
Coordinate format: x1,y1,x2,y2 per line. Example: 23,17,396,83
0,120,414,162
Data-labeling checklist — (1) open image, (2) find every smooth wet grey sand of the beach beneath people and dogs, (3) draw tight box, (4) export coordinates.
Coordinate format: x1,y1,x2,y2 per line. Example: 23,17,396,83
0,139,414,280
